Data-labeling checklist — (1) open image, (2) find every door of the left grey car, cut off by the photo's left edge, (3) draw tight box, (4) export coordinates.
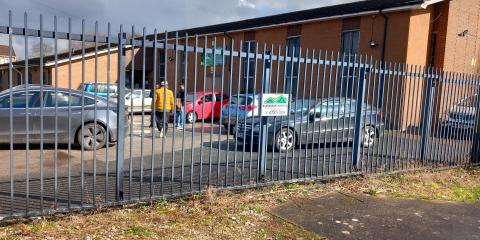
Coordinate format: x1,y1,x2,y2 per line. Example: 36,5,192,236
0,91,39,143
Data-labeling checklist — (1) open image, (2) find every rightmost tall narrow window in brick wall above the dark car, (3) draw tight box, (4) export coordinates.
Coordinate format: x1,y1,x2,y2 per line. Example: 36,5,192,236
339,30,360,97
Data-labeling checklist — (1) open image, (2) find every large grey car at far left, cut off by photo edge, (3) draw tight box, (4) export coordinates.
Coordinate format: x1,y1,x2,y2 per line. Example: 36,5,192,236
0,85,127,150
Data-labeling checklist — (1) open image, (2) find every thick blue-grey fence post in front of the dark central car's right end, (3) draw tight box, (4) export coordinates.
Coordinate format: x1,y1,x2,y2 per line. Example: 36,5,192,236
352,66,369,169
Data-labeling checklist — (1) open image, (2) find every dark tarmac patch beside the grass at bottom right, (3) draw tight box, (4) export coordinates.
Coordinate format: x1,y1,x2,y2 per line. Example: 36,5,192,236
273,192,480,240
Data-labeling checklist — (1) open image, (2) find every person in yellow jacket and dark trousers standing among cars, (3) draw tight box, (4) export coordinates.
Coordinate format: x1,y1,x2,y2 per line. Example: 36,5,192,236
154,81,175,137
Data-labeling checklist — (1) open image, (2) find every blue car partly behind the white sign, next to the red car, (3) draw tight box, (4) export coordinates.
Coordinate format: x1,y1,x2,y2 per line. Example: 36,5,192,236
222,94,260,134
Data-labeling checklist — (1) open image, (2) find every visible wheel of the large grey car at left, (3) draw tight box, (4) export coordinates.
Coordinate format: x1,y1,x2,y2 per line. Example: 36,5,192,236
77,123,107,151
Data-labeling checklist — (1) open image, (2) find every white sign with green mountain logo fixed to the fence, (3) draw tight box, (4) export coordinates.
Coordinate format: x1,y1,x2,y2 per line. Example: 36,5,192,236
261,94,290,117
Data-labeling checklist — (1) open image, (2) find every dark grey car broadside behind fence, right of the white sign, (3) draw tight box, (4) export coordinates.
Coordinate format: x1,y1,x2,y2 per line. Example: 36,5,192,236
234,98,385,151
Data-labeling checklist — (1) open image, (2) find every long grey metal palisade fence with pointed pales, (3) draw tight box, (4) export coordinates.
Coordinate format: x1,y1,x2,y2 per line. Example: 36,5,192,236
0,13,479,218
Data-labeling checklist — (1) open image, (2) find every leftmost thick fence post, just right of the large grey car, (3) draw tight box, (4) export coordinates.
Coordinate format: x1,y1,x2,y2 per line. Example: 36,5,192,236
115,28,126,201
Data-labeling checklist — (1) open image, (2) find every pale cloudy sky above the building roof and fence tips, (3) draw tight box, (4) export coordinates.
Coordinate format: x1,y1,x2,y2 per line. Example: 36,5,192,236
0,0,358,58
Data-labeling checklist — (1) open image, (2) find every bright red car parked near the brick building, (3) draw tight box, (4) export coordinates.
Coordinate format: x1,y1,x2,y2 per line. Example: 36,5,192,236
185,92,230,123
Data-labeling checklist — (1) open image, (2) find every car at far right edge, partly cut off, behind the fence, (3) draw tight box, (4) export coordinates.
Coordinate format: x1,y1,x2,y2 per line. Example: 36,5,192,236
445,94,478,130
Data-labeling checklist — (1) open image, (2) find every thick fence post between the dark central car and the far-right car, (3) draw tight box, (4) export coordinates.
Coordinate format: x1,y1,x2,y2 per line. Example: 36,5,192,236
420,71,436,162
